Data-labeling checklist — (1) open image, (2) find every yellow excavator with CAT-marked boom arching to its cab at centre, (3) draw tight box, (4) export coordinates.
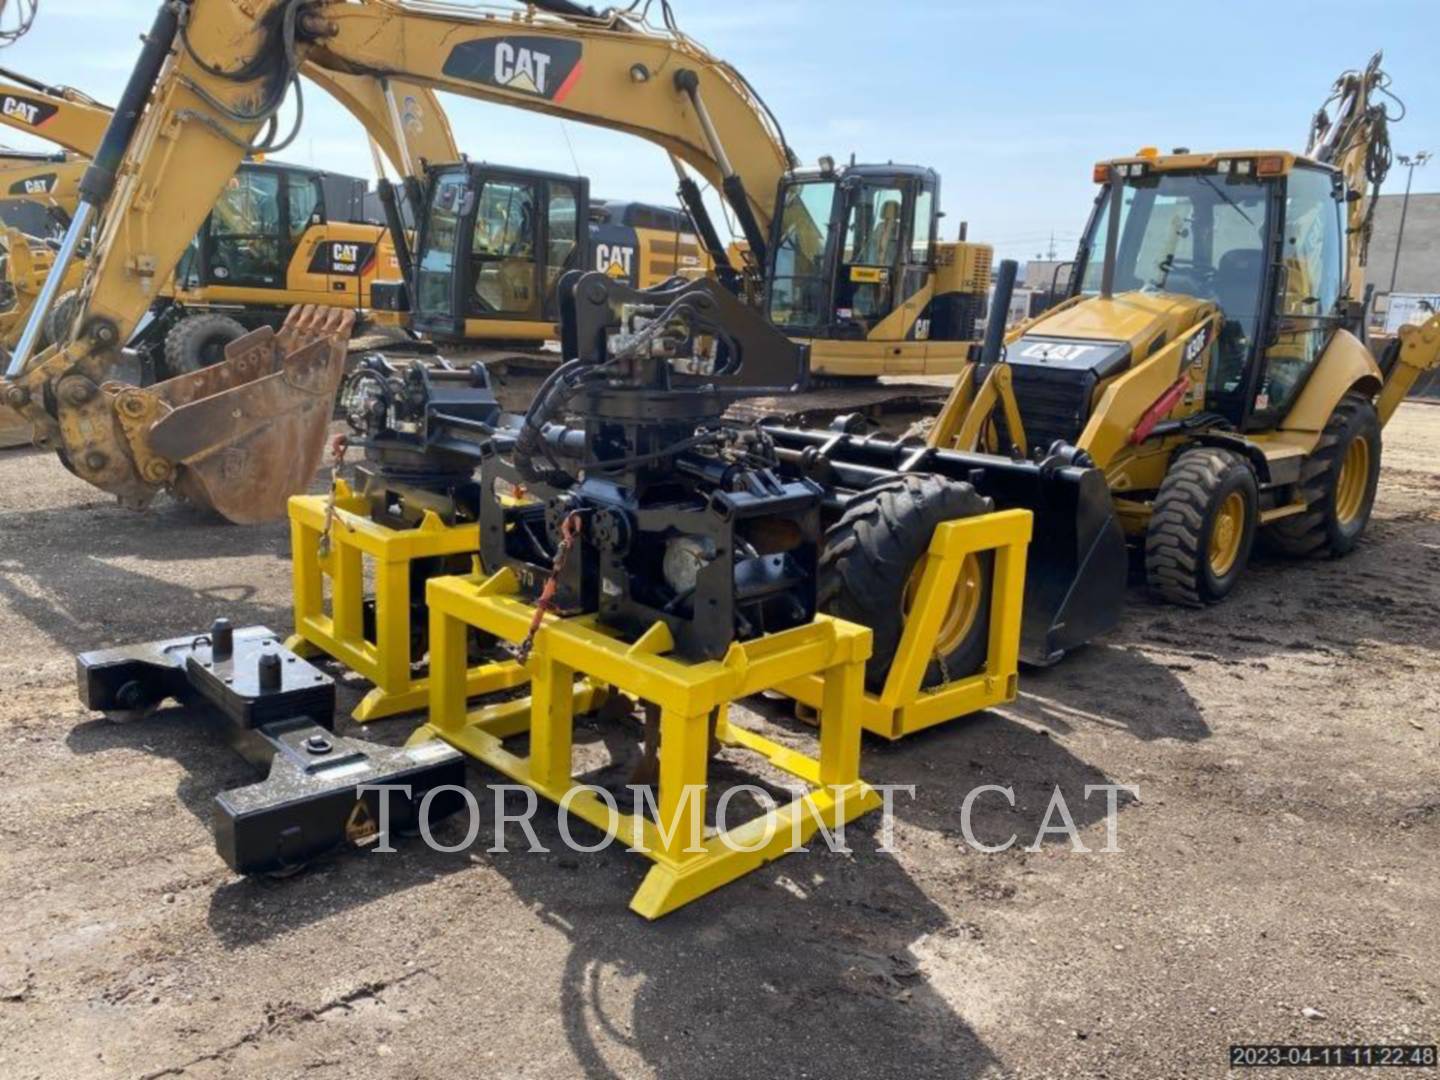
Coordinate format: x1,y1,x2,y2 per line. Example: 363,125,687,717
6,0,988,517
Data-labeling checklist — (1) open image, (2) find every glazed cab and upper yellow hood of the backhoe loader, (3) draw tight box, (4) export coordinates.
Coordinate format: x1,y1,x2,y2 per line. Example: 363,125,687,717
1071,151,1354,431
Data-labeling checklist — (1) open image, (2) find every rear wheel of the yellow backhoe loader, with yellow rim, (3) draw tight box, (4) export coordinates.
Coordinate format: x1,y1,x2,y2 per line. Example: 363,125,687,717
1263,393,1381,559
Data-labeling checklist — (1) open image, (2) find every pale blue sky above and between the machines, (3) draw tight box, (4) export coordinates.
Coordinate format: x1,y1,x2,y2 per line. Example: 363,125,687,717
0,0,1440,261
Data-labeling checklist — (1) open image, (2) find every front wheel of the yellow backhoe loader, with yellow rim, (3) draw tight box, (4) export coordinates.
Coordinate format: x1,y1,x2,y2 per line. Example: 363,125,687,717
1145,446,1260,608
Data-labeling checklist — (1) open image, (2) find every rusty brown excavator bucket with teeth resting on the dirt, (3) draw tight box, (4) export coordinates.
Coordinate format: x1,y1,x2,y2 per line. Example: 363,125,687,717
148,305,354,524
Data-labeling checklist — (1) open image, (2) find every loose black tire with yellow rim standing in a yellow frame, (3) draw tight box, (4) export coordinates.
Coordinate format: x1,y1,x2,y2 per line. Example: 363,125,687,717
819,475,994,691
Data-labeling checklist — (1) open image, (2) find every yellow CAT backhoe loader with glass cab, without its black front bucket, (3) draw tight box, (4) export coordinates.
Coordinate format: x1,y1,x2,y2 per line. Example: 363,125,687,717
929,55,1440,616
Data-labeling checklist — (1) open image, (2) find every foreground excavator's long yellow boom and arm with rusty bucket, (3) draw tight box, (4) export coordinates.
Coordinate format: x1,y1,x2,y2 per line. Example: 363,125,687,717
3,0,792,520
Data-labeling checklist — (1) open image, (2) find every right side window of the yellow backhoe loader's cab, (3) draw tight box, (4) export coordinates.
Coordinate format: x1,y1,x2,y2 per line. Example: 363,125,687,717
1254,167,1345,416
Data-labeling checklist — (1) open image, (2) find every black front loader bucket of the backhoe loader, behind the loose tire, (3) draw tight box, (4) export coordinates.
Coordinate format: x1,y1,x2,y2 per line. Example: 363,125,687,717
766,426,1129,665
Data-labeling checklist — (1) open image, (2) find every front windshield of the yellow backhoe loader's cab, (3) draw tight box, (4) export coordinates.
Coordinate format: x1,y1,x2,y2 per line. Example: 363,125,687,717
1080,173,1269,403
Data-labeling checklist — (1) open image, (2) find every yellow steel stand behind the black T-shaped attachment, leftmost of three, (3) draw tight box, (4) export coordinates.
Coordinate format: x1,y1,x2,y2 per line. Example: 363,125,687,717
285,481,528,723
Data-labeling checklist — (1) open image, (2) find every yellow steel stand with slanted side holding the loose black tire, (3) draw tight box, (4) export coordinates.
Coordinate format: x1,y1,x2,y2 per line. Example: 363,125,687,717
779,510,1034,739
